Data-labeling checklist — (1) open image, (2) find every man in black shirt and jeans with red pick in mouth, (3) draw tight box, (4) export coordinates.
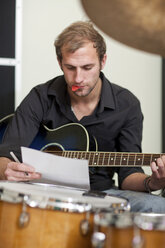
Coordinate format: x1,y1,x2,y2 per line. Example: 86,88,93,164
0,22,165,212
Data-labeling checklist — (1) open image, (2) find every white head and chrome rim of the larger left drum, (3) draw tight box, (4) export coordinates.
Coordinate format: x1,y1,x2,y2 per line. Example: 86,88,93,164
0,181,129,212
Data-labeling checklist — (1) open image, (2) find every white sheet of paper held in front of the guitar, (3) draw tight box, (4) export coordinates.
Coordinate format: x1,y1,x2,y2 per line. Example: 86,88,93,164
21,147,90,190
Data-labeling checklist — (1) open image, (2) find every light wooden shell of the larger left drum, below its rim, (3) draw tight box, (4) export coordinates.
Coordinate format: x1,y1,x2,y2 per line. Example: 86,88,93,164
0,201,93,248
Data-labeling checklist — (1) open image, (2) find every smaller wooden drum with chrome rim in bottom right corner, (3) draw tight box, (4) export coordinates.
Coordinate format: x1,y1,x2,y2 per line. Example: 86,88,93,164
92,212,165,248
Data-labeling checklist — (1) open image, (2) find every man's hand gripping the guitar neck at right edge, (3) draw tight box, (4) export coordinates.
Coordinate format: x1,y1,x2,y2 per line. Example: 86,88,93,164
150,155,165,190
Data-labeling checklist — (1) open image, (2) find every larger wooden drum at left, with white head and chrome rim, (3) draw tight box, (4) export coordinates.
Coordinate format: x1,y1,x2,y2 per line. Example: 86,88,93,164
0,181,128,248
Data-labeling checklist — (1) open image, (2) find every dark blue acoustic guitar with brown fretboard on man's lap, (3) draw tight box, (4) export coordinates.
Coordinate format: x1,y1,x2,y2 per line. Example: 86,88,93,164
0,114,162,167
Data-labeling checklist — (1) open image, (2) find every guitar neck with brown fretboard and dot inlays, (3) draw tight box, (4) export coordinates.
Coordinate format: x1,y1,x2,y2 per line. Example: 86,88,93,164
45,151,163,167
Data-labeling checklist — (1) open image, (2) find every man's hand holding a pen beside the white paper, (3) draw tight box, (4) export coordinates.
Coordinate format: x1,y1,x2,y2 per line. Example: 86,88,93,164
4,162,41,181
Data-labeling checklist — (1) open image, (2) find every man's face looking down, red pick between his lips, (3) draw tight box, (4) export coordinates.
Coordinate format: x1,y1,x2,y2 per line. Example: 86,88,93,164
59,42,106,97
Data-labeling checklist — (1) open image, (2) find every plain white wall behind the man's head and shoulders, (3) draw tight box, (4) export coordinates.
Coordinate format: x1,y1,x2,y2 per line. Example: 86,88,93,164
21,0,161,173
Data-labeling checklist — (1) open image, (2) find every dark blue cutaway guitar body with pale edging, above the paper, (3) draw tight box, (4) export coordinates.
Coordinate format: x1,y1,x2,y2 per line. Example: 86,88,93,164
30,123,89,151
